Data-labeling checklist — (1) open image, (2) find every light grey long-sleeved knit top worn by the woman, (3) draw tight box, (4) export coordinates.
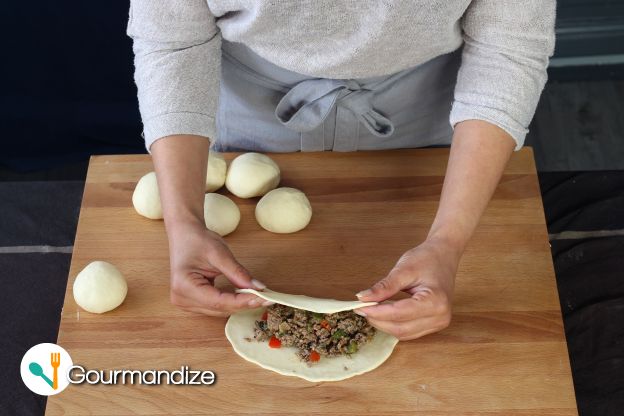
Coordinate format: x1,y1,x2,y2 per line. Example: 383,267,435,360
128,0,555,149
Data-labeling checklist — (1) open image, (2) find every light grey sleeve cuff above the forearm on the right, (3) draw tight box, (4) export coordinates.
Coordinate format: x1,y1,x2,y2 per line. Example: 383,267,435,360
450,101,529,151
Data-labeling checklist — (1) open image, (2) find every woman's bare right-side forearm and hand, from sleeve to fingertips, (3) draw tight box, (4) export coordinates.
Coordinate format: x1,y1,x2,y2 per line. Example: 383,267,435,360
356,120,515,340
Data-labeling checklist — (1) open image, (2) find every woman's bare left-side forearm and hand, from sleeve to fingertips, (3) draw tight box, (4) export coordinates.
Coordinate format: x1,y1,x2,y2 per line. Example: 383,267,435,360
150,135,264,316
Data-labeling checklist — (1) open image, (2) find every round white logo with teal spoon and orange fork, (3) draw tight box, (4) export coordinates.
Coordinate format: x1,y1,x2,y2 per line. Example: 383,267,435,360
20,343,74,396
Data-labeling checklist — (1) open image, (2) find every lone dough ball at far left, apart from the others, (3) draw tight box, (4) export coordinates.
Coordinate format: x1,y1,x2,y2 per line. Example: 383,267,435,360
73,261,128,313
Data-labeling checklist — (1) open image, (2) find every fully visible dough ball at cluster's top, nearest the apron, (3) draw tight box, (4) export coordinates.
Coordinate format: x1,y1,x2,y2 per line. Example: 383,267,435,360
225,153,280,198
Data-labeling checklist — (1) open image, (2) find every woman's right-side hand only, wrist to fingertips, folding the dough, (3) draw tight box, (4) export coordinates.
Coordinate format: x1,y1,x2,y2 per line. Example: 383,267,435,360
354,240,461,340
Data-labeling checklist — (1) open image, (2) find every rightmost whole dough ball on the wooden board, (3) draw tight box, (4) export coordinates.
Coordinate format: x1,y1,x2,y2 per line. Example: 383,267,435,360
256,188,312,234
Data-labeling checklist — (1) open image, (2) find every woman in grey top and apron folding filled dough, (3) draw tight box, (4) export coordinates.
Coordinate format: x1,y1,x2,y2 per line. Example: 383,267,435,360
128,0,555,340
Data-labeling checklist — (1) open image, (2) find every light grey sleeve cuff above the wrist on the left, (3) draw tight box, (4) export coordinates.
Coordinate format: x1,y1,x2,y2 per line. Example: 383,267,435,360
143,113,216,153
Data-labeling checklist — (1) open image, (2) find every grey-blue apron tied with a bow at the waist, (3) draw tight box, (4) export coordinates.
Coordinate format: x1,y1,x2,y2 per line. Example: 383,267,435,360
213,40,461,152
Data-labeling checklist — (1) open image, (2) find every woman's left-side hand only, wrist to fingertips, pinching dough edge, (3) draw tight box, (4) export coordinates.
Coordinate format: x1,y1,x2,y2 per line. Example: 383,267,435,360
167,221,271,316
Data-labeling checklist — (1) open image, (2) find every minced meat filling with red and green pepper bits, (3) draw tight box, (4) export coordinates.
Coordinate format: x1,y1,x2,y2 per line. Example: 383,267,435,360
254,305,375,363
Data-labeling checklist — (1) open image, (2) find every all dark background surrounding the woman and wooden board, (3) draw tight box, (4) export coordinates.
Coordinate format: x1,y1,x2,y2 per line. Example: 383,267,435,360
0,0,624,416
